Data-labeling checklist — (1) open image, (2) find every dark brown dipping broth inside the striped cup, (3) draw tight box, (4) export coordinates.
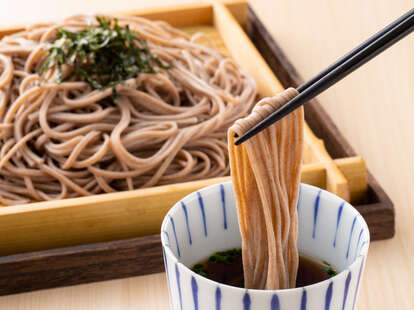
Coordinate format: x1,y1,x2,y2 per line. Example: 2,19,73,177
191,249,338,288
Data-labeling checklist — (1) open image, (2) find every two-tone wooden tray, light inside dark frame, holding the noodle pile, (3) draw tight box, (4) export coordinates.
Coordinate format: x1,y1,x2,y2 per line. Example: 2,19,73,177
0,1,394,295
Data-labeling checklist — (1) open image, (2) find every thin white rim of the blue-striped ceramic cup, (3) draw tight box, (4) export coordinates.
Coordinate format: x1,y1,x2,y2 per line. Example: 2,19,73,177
161,181,371,295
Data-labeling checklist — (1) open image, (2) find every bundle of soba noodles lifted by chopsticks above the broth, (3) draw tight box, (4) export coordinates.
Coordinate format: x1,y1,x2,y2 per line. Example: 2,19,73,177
228,88,304,289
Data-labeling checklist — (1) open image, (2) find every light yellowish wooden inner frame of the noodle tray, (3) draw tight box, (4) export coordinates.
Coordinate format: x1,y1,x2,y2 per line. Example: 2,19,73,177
0,0,365,255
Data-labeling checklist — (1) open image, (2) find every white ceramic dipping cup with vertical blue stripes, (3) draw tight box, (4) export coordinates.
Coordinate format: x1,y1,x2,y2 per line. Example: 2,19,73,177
161,182,369,310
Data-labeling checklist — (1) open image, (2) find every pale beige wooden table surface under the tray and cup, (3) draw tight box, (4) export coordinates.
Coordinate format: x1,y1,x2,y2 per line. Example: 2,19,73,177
0,0,414,310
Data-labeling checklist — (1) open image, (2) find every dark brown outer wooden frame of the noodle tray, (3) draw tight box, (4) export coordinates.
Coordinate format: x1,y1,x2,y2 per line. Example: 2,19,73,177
0,1,394,295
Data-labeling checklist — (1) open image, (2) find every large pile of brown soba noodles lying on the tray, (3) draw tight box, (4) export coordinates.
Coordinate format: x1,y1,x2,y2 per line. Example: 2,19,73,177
0,16,256,205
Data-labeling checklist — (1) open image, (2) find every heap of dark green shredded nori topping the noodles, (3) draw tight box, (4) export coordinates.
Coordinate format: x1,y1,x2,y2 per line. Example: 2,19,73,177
39,17,170,99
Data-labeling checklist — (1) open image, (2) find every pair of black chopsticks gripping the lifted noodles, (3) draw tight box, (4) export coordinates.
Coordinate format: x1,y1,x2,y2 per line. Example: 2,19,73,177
235,9,414,145
